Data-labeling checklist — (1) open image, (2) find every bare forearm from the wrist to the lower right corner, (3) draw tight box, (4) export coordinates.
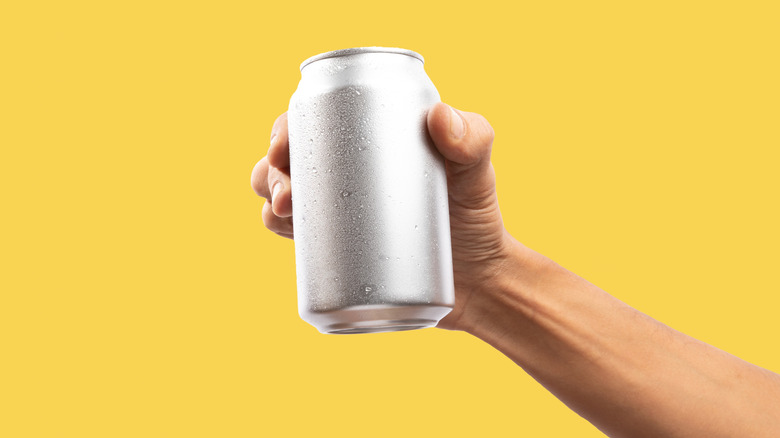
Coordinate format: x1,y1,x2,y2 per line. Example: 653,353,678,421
460,236,780,438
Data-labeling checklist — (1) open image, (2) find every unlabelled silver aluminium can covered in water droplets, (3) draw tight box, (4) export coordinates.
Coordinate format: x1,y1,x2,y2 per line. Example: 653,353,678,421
288,47,455,333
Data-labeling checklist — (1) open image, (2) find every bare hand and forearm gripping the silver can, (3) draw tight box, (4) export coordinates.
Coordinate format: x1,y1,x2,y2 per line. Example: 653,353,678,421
252,103,780,438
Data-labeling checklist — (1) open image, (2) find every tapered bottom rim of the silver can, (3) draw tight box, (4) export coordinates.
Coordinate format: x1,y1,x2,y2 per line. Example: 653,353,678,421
301,304,452,335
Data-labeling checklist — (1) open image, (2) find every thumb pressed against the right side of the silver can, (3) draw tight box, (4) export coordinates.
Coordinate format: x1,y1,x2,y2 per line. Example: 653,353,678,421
428,102,496,209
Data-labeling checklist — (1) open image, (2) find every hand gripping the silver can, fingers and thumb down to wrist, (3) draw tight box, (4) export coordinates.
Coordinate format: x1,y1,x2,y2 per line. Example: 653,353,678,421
252,103,515,330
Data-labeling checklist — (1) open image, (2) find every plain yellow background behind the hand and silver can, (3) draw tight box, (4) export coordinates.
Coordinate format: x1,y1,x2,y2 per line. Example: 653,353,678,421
0,1,780,437
